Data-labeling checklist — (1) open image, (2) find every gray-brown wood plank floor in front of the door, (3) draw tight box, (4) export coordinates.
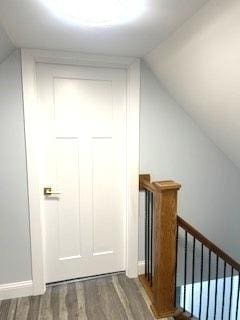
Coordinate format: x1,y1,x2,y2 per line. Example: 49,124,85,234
0,274,171,320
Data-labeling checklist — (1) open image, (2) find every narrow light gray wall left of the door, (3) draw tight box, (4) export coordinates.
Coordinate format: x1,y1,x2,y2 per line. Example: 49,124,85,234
0,51,32,284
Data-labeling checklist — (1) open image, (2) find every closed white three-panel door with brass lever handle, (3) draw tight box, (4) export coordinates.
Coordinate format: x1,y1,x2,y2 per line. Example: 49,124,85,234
37,64,126,282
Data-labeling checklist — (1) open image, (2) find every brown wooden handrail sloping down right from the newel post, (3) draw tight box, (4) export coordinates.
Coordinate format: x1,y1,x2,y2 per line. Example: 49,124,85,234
177,216,240,272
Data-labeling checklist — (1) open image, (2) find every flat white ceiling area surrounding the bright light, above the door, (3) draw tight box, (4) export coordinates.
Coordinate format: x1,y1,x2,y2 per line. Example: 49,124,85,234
0,0,207,56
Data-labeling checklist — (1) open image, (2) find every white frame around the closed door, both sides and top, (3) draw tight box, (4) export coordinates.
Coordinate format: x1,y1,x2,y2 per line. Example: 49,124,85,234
21,49,140,295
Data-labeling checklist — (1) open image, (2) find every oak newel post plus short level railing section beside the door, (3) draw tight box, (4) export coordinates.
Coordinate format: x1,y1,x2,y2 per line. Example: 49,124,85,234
139,174,181,318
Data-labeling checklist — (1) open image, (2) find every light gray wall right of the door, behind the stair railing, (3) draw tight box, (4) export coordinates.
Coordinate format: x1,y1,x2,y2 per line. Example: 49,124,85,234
139,62,240,260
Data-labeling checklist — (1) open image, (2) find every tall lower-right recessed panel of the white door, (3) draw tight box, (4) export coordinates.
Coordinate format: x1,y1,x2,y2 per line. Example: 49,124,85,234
92,138,116,255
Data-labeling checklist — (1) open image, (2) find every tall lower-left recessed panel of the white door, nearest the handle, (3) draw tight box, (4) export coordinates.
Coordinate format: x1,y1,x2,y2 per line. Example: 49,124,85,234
56,138,81,260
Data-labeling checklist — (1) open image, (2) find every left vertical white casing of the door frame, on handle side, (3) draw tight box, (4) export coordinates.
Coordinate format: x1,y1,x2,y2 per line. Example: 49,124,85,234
21,50,46,295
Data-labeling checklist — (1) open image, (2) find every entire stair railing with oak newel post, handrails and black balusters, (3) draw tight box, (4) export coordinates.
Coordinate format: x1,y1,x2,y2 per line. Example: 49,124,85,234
139,174,240,320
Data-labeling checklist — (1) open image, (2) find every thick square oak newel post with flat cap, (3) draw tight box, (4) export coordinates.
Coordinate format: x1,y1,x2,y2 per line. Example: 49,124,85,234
152,181,181,318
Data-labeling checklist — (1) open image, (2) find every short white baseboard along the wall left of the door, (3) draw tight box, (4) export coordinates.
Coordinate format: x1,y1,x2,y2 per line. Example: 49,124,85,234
0,280,33,300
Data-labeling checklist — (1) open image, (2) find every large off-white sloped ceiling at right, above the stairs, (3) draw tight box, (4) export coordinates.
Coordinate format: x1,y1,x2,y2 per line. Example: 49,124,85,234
145,0,240,168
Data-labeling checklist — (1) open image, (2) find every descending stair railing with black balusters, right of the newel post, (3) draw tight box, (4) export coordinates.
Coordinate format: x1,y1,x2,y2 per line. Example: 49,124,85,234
176,216,240,320
